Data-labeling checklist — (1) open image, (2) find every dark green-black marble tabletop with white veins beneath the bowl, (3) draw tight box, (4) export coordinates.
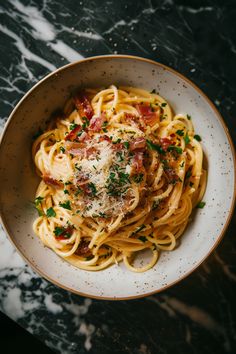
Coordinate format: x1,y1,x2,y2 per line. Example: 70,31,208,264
0,0,236,354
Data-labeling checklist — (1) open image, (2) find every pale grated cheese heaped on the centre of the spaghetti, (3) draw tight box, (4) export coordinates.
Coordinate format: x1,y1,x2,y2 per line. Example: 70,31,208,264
73,139,132,217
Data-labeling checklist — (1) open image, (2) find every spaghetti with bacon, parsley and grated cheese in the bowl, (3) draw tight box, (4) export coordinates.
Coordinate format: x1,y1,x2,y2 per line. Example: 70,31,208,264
32,85,206,272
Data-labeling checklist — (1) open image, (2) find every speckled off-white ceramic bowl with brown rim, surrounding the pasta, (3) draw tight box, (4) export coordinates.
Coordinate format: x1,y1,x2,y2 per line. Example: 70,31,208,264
0,55,235,300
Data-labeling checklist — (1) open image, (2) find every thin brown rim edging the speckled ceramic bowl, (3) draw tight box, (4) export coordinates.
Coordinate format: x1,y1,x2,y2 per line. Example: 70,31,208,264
0,54,236,301
